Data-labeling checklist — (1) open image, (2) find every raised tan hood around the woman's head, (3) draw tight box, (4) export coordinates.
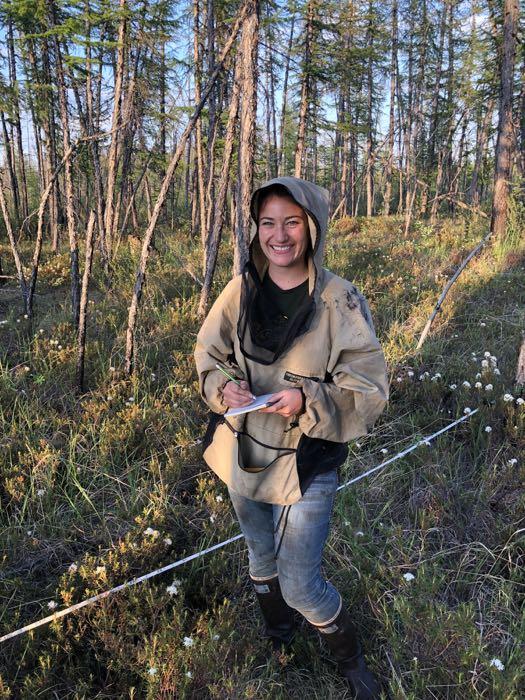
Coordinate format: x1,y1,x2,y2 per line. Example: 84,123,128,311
250,176,328,297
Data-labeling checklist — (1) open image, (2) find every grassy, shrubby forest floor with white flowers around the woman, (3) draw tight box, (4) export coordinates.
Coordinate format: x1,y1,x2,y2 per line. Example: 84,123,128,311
0,211,525,700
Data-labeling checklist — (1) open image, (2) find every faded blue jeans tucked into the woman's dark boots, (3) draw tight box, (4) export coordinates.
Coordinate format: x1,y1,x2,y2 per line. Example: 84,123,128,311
229,469,341,625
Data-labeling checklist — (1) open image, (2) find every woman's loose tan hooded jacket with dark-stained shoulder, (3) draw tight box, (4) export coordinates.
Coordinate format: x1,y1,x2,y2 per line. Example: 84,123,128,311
195,177,388,505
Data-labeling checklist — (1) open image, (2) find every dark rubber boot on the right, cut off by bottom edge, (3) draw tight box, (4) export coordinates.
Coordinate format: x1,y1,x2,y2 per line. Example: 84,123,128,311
315,607,381,700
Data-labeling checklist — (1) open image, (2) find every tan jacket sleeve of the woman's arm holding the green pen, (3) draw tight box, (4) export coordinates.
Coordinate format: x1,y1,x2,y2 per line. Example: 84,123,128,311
194,278,244,413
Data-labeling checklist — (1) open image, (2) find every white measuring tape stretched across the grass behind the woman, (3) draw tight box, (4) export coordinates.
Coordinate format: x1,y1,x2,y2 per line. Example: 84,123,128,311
0,408,479,643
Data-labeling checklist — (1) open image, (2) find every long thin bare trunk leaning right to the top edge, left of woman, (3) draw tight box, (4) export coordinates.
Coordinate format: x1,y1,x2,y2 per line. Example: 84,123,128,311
125,2,251,374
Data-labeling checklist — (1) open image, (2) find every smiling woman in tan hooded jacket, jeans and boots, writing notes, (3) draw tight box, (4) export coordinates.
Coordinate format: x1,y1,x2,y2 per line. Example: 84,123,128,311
195,177,388,700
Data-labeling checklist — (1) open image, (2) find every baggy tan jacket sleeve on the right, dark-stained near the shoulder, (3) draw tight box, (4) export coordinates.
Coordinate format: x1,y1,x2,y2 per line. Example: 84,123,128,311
299,290,388,442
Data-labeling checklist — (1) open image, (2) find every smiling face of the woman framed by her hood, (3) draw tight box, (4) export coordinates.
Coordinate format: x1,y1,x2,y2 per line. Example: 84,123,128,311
258,195,310,274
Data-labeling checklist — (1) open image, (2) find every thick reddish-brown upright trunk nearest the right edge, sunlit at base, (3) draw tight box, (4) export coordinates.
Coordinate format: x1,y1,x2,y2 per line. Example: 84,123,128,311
490,0,519,236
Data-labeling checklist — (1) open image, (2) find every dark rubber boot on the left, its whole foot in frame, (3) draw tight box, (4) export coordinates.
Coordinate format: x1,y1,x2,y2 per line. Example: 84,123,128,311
250,576,295,651
